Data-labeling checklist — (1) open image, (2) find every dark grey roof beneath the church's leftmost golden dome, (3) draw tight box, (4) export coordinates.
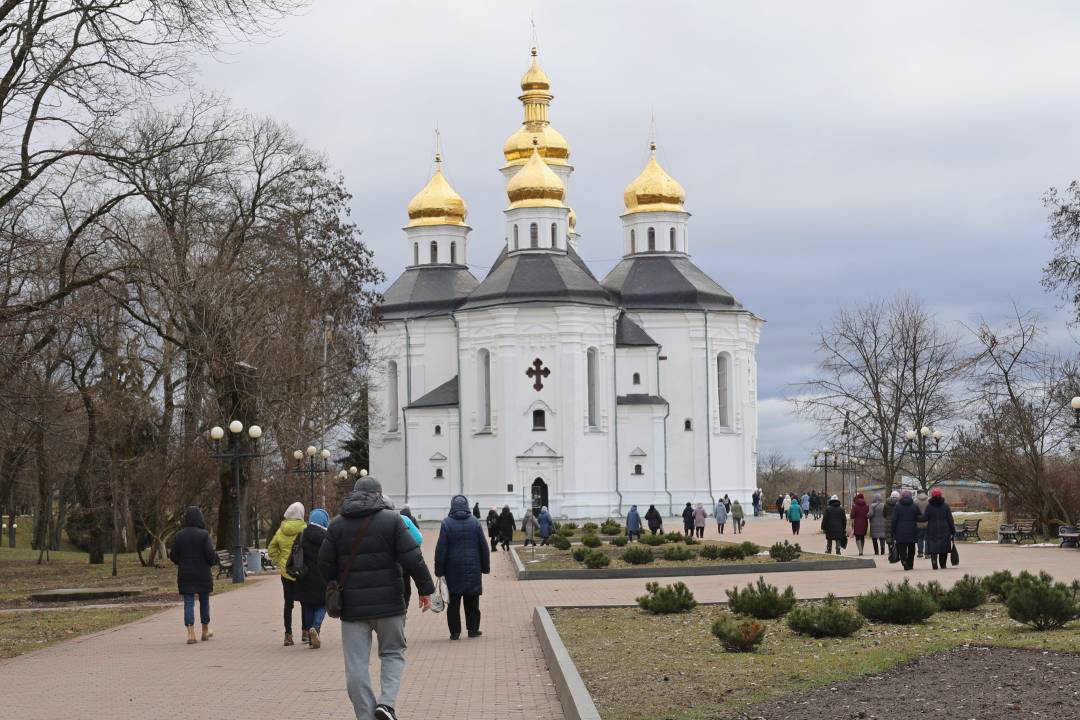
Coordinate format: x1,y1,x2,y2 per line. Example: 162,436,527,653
379,264,480,320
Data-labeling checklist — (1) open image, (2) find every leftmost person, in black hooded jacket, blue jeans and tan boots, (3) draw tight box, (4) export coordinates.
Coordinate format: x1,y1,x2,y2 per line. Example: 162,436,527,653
168,505,218,646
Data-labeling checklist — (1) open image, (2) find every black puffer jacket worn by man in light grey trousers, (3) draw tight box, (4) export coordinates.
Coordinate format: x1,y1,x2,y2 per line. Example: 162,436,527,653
319,475,435,621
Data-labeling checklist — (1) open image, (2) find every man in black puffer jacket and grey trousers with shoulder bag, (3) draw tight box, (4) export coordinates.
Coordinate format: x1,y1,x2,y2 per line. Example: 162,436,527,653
319,476,435,720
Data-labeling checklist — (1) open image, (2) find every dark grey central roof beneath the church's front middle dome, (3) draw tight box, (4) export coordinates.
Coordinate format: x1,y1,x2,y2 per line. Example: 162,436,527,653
461,248,615,310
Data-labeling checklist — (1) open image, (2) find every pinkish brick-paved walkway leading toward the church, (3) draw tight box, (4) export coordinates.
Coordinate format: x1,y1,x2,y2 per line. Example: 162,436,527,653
0,518,1080,720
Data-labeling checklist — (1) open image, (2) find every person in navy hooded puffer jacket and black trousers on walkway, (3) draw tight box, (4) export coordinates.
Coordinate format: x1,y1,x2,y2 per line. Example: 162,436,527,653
435,495,494,640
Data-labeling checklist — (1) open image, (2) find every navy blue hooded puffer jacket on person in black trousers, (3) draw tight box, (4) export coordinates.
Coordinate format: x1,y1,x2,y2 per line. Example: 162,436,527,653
435,495,491,595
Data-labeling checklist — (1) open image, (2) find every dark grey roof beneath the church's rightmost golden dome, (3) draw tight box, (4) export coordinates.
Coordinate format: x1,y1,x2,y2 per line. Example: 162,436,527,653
600,255,743,310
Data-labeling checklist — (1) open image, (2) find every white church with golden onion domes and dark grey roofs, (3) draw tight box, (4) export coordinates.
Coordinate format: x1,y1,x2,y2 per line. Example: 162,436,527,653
369,49,762,518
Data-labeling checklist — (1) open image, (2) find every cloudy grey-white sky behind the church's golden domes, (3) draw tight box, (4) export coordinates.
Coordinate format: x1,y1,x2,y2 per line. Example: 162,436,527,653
201,0,1080,461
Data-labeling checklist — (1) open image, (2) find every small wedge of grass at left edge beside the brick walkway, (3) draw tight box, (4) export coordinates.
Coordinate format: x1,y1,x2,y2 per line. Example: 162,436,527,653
0,608,154,660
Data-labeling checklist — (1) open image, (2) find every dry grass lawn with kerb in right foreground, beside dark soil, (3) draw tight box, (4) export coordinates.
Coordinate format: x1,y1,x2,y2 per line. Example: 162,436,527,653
551,603,1080,720
